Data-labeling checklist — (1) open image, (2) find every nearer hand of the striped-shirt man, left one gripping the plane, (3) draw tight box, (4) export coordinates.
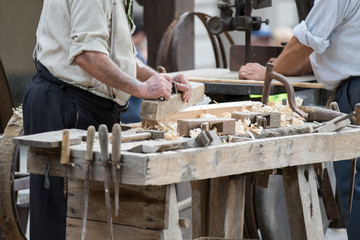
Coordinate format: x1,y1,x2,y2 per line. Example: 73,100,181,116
140,73,172,100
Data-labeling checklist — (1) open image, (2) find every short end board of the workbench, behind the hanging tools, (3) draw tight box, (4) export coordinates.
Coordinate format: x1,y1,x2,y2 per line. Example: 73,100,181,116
27,147,147,185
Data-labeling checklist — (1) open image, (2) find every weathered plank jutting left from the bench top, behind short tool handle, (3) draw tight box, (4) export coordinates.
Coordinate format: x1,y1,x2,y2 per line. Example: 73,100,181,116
14,129,86,148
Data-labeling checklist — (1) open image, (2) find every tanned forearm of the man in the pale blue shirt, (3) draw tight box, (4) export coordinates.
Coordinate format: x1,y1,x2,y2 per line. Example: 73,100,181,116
274,37,313,75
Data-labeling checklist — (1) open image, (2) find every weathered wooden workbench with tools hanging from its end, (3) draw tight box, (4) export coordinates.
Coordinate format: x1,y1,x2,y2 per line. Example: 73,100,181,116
17,126,360,239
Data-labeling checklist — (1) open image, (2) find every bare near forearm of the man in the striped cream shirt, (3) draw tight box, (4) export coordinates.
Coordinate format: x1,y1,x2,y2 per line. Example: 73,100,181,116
74,51,142,97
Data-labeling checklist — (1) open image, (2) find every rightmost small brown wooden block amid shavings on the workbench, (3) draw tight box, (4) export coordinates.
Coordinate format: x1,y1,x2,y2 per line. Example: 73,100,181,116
231,112,281,128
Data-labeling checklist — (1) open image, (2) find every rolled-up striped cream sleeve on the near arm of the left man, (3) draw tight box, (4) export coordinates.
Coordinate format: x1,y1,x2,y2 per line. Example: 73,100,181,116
68,0,111,64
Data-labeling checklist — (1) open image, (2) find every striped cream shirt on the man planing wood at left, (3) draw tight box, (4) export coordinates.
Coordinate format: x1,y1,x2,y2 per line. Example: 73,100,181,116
34,0,136,105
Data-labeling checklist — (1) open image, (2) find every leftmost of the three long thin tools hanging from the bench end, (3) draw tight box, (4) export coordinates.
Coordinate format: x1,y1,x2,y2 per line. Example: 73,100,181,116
81,126,95,240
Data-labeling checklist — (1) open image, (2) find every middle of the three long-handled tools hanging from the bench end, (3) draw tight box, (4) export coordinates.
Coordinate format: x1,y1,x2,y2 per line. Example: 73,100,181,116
98,124,114,240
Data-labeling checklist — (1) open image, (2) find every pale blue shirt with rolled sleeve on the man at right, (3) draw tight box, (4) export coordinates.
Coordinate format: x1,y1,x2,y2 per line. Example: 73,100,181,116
294,0,360,90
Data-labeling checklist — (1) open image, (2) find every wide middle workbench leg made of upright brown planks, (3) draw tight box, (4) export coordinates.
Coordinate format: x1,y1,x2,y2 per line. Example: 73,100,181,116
191,175,246,239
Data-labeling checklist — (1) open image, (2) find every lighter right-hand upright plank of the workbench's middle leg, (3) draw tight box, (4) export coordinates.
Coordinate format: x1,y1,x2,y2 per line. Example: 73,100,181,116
224,175,246,239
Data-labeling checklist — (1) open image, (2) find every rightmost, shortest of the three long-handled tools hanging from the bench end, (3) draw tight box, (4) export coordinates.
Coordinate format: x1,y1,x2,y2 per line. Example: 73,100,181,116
111,124,121,216
